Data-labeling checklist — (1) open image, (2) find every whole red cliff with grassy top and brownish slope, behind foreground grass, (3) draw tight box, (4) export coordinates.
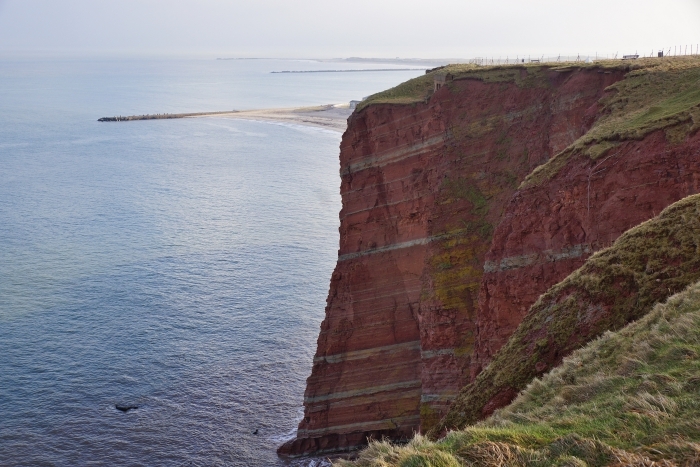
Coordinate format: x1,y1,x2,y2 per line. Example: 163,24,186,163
290,57,700,464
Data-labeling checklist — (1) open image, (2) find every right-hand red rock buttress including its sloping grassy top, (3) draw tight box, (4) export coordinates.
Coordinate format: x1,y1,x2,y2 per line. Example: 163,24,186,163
475,61,700,384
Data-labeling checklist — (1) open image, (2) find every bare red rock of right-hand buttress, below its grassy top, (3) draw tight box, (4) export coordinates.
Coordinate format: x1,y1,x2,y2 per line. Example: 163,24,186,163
475,130,700,376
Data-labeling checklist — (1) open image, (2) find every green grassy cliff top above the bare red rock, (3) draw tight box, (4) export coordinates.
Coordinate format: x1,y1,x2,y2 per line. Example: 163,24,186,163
356,56,700,189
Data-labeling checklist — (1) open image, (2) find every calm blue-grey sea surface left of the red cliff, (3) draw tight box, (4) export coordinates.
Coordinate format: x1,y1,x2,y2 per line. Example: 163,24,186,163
0,59,421,466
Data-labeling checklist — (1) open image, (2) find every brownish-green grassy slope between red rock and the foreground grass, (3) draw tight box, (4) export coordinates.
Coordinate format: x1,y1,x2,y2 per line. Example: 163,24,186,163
431,195,700,435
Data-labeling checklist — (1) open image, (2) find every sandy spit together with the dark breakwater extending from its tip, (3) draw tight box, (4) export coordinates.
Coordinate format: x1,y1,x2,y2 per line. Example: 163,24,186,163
98,104,353,133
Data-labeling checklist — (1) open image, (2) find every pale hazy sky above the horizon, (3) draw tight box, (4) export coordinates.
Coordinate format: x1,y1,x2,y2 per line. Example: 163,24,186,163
0,0,700,58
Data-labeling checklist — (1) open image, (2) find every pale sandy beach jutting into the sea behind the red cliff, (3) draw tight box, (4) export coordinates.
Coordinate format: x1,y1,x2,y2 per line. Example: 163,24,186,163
206,104,352,132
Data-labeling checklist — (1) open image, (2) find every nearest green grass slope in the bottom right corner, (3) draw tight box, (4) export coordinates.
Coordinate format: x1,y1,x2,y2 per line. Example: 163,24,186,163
336,283,700,467
